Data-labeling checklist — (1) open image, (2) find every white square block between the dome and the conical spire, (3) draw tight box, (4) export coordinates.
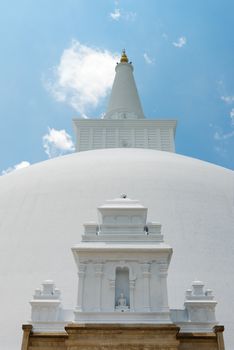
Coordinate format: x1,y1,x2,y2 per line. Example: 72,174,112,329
73,118,176,152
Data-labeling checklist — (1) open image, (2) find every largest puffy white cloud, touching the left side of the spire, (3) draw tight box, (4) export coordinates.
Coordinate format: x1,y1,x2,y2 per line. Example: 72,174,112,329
45,40,119,115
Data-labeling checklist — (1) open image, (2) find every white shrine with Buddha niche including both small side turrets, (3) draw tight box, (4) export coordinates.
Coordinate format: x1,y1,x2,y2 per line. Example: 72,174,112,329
30,194,217,333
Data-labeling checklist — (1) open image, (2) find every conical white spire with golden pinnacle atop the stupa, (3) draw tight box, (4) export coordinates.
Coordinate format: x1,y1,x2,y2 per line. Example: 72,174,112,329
104,49,145,119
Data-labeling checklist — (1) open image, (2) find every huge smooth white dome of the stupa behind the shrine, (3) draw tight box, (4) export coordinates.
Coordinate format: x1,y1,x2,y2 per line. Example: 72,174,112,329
0,149,234,350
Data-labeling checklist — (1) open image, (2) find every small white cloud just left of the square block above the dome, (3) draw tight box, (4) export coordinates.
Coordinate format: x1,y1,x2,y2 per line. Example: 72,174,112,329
42,128,75,158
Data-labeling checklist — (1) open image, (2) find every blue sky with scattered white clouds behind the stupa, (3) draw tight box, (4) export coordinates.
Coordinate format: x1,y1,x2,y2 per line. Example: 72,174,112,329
0,0,234,174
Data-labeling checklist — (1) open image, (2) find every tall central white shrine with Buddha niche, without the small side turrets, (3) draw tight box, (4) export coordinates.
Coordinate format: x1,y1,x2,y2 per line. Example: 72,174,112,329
72,195,172,323
